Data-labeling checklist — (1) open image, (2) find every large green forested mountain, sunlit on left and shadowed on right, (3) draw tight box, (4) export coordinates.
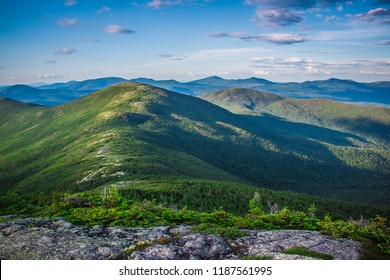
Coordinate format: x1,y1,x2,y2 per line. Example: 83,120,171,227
0,83,390,215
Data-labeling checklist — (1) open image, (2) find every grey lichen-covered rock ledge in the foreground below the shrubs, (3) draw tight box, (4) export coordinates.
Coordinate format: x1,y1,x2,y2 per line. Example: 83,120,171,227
0,218,360,260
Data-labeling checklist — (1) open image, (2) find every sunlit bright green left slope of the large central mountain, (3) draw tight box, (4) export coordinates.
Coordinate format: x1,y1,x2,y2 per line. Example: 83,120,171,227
0,83,241,195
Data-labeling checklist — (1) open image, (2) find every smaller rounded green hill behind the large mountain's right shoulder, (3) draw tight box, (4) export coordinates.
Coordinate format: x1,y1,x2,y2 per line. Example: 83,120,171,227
200,88,390,149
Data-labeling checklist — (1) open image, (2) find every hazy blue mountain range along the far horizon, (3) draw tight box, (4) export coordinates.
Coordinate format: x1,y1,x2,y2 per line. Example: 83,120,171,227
0,76,390,106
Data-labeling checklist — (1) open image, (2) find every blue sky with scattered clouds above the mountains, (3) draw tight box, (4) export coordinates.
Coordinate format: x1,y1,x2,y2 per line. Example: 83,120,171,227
0,0,390,85
